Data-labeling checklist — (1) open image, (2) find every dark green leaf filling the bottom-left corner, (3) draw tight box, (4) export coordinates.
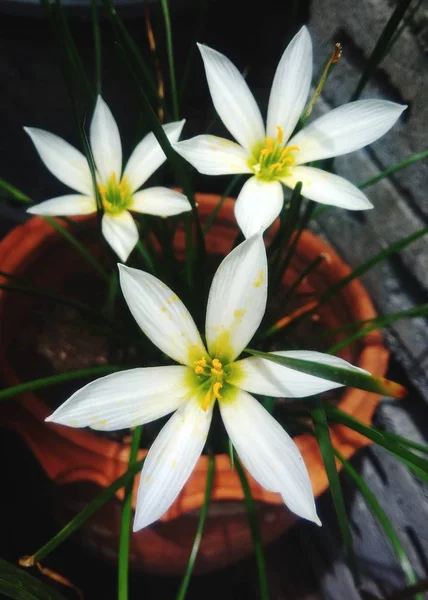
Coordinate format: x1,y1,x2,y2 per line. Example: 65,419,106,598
0,558,65,600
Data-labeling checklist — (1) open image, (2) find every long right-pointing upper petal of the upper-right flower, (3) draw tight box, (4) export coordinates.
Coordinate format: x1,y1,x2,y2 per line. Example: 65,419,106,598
289,100,407,165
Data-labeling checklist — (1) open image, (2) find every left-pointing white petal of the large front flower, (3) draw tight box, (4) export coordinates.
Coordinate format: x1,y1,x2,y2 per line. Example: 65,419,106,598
46,366,188,431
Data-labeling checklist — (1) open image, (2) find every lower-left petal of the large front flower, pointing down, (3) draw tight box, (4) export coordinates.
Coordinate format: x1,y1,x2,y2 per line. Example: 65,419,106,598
134,400,212,531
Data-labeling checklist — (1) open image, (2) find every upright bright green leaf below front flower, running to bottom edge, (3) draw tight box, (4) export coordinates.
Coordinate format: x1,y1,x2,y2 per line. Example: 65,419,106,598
117,425,143,600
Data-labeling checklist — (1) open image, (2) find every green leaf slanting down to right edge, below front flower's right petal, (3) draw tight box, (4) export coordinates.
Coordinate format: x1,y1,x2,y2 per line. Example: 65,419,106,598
326,406,428,483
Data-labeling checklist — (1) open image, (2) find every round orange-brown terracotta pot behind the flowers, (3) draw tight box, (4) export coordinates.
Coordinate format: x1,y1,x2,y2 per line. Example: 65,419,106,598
0,194,388,574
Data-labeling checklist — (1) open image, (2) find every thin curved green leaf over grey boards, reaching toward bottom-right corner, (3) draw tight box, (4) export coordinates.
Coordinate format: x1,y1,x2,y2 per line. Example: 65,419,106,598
334,449,423,600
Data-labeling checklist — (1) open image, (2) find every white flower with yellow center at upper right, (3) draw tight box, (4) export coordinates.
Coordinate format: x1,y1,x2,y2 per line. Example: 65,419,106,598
174,27,406,237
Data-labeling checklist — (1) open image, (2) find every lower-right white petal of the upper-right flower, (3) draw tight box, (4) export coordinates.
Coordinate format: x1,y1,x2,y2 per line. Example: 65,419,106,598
282,167,373,210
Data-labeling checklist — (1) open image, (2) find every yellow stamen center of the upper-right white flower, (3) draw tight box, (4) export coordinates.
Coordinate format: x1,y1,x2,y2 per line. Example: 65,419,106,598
248,125,300,181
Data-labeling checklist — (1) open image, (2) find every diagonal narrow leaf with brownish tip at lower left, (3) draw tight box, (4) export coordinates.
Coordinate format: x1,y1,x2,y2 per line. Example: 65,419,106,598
20,458,145,567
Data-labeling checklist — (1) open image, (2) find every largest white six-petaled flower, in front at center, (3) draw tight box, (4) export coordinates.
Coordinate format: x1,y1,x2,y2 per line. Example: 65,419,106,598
47,234,361,530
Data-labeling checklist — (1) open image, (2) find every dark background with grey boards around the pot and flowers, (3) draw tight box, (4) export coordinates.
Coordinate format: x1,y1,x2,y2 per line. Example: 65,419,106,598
0,0,428,600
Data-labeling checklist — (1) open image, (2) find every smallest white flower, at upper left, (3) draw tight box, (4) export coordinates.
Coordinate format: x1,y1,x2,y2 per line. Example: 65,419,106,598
24,96,191,261
